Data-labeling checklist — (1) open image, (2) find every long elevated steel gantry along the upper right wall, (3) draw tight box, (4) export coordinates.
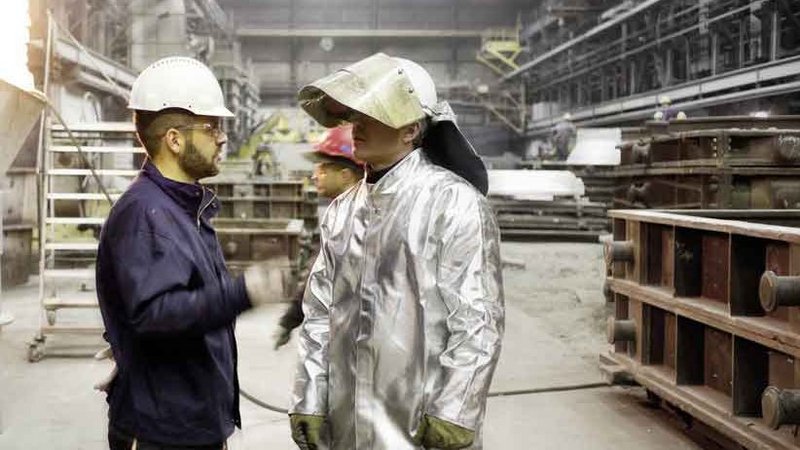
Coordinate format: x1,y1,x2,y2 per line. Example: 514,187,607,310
510,0,800,133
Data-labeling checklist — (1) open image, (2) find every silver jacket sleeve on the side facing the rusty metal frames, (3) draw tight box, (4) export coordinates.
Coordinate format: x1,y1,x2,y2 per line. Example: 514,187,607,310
427,188,504,430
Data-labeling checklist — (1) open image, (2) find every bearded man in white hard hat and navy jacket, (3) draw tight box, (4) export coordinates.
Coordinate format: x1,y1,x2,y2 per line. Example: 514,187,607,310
97,57,282,450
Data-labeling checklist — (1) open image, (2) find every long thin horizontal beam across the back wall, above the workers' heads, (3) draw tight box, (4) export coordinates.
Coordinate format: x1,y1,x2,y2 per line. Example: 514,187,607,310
236,28,483,39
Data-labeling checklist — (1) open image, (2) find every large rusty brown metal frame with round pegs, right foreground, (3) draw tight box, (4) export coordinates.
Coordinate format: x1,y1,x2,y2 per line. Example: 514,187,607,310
606,210,800,448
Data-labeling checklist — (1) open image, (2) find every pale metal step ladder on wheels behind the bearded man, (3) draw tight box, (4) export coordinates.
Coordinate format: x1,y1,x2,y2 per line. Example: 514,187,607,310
28,122,145,362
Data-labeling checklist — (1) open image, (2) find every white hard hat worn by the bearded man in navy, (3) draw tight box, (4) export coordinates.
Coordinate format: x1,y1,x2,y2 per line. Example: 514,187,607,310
128,56,233,117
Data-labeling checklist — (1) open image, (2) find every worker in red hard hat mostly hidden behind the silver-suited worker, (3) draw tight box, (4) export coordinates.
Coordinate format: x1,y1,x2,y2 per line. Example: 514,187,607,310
275,124,364,350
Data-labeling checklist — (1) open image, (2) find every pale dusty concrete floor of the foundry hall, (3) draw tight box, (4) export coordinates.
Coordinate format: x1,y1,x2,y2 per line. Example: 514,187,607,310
0,243,702,450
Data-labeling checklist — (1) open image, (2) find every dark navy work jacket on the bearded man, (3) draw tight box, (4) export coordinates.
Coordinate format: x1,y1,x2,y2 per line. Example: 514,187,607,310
97,162,250,445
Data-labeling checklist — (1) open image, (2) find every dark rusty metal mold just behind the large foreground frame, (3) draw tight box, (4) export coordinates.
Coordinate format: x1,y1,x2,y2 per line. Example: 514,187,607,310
612,126,800,209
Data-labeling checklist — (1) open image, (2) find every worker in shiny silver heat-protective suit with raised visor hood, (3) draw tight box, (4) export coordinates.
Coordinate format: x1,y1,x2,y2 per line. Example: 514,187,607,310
290,53,504,450
